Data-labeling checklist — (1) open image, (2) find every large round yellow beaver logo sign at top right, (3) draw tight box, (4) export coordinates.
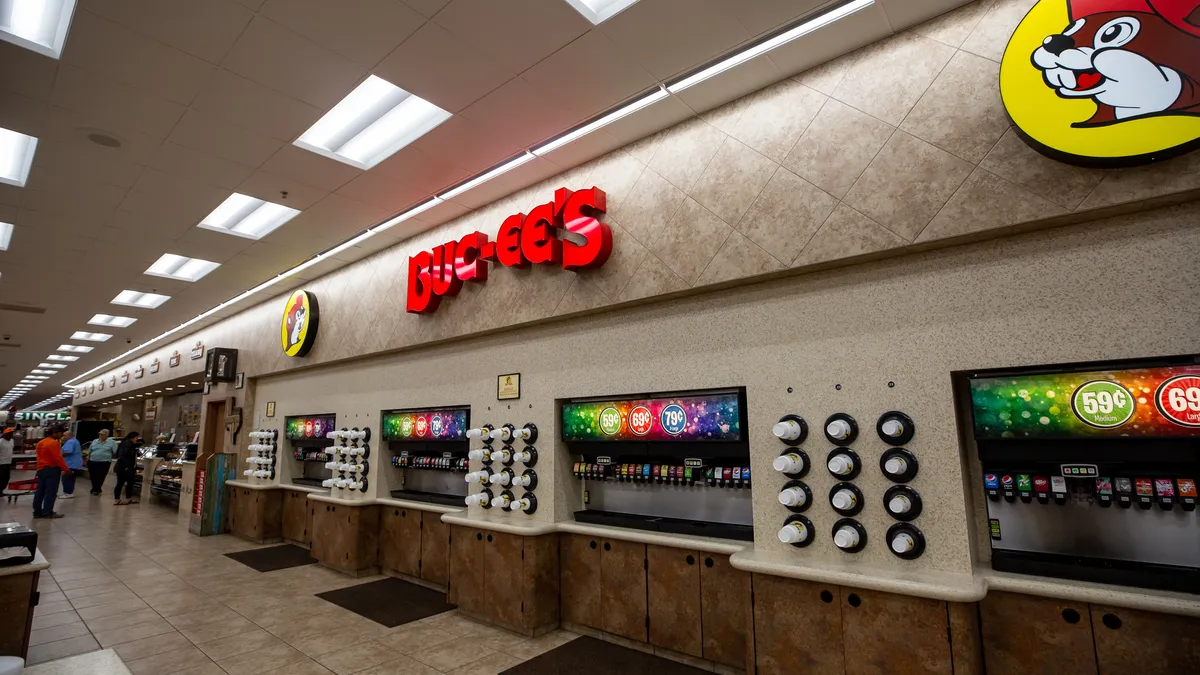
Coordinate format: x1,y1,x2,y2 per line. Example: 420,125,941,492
1000,0,1200,167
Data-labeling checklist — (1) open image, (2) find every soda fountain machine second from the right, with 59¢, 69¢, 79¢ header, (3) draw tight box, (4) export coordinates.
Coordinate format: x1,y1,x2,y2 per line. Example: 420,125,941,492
560,388,754,540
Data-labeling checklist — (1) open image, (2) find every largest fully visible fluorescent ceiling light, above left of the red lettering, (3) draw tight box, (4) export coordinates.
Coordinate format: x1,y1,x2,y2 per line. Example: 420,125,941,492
295,76,450,169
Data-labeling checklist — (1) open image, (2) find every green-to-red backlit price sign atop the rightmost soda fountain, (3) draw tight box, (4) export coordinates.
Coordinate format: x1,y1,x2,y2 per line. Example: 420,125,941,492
971,365,1200,438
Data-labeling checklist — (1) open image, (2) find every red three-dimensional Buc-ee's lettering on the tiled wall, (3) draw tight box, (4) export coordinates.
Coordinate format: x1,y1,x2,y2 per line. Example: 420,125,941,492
406,187,612,313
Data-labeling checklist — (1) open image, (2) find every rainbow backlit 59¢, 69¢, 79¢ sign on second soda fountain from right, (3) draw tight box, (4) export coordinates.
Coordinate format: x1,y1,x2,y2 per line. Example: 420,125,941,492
563,392,742,442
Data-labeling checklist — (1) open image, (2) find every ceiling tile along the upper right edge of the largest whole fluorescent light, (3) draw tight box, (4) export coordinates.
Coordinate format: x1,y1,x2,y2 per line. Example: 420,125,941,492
372,22,512,113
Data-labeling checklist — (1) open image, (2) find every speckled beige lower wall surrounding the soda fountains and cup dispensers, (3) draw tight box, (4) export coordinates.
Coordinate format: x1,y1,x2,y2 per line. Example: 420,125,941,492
253,205,1200,577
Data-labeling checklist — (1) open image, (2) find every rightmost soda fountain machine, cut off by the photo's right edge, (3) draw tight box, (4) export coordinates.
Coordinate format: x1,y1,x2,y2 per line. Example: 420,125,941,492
964,356,1200,593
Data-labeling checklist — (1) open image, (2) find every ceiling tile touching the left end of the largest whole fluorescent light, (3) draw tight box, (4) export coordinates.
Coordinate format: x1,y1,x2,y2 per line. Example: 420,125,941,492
191,68,323,142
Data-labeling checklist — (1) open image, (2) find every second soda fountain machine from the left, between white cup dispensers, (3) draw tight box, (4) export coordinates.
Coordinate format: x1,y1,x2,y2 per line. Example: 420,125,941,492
382,406,470,506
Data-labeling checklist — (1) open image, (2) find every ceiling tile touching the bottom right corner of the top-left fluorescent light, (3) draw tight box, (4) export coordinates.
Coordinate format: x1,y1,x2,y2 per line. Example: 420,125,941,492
50,65,186,138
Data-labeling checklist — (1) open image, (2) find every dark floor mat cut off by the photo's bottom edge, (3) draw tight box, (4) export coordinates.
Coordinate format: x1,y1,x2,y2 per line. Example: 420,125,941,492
500,637,710,675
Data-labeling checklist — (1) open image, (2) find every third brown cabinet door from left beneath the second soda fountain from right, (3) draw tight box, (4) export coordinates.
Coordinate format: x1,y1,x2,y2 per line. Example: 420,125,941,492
646,545,704,657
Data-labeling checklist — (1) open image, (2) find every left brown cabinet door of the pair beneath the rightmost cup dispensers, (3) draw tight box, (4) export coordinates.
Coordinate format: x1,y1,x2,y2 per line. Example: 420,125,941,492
754,574,846,675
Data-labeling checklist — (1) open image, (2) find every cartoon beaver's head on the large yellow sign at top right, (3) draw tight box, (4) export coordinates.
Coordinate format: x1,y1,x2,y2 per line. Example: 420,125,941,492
1032,6,1200,126
